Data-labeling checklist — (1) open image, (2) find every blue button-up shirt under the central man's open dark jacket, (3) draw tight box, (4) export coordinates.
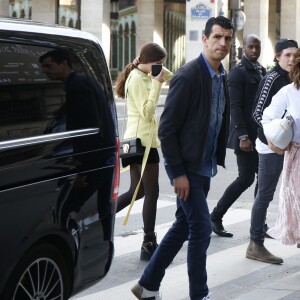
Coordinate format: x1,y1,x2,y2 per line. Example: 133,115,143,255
200,53,226,177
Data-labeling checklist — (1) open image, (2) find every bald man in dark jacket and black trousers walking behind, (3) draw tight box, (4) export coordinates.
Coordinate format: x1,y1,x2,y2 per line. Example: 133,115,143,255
211,34,266,237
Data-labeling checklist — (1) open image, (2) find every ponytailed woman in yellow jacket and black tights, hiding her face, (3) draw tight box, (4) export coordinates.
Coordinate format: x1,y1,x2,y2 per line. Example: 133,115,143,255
116,43,173,261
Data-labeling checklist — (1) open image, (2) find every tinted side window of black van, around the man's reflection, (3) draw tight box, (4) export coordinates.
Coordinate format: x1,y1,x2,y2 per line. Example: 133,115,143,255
0,42,111,141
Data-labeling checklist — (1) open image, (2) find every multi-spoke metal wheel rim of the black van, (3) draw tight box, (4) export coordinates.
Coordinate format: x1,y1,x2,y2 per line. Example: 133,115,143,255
13,258,64,300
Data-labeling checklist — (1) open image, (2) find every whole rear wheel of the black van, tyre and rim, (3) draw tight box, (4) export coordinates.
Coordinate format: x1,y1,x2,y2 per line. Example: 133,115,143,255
2,244,70,300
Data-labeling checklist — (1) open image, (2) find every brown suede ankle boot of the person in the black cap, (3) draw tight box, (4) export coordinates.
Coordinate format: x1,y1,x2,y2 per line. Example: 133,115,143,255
246,240,283,264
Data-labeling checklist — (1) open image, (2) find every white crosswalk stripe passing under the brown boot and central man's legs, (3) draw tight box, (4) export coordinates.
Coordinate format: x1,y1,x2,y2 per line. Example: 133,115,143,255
72,239,299,300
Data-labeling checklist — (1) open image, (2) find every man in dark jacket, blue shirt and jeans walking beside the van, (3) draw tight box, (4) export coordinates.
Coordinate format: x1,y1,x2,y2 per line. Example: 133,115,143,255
132,17,233,300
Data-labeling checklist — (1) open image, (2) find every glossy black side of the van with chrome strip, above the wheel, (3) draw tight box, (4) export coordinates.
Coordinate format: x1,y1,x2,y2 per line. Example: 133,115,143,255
0,34,116,288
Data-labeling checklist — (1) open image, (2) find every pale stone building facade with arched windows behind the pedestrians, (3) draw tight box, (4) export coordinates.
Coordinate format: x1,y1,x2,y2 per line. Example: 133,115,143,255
0,0,300,76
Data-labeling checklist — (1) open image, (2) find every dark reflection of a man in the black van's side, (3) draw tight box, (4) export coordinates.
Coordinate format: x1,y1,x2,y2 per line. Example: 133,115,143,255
39,49,115,173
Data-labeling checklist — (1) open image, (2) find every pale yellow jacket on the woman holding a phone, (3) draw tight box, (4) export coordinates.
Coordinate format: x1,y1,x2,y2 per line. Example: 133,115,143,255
124,67,173,148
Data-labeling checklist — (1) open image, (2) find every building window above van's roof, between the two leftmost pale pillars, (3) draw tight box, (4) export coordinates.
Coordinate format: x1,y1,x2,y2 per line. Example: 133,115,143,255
57,0,80,29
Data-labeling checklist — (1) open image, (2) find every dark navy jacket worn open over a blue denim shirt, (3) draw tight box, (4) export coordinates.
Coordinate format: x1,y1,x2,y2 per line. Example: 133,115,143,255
158,55,229,178
